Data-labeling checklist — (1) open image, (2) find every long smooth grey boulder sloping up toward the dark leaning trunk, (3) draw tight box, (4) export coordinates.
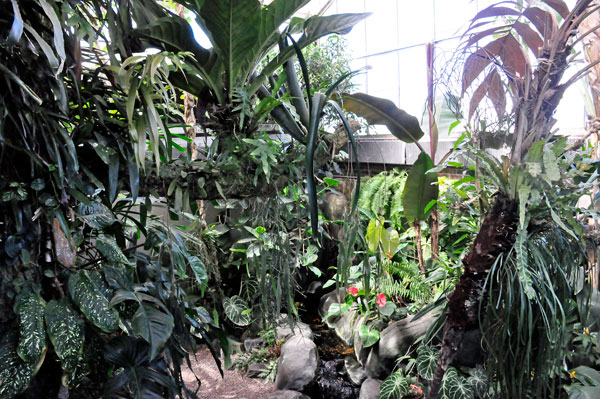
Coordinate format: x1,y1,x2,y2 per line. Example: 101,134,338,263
365,313,438,379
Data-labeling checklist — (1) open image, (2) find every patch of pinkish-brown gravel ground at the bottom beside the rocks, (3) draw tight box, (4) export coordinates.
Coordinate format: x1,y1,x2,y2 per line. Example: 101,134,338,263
183,346,275,399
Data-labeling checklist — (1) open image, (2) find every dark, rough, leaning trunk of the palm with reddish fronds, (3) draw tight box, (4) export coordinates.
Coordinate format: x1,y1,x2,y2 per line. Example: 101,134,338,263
431,194,519,399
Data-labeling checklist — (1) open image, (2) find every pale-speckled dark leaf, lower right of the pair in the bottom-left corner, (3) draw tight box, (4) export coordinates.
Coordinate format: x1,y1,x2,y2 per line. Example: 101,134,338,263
44,298,85,373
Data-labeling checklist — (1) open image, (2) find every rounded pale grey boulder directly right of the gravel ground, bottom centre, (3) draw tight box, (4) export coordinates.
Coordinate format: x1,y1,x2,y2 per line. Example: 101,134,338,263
275,335,319,391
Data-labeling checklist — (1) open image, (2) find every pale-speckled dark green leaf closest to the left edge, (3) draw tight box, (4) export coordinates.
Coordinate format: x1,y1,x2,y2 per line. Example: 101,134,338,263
15,291,47,364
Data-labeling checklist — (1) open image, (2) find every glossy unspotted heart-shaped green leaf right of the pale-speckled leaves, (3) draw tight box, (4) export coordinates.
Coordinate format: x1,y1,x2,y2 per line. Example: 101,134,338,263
131,303,173,359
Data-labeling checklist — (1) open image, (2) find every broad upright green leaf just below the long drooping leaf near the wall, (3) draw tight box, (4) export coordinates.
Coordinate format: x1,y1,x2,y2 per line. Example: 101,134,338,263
402,152,439,222
